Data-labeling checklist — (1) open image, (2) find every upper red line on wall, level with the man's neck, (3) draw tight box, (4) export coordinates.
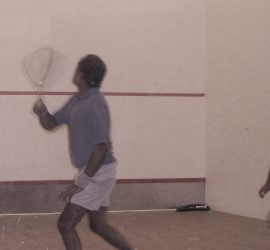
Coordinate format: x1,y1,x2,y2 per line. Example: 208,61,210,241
0,91,205,97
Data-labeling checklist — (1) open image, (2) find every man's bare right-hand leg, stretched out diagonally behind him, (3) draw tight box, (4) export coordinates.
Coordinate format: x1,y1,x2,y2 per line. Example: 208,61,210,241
89,207,134,250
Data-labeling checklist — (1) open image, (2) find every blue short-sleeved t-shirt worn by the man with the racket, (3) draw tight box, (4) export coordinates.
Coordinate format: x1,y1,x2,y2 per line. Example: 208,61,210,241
54,88,115,168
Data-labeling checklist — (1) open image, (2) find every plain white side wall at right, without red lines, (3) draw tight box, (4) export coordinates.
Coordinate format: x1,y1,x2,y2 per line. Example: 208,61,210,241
206,0,270,219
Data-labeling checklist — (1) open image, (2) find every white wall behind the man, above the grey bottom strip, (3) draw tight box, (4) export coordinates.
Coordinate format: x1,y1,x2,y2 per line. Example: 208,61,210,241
0,0,205,181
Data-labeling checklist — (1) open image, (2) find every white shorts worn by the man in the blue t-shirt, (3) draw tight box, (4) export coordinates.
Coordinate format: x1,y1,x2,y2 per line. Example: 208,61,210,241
70,162,116,211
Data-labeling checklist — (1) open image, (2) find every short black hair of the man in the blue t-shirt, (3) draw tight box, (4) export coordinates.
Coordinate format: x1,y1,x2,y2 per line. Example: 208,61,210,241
78,54,107,87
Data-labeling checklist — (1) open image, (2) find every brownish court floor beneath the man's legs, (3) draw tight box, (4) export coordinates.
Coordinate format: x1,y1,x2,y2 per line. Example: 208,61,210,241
0,211,270,250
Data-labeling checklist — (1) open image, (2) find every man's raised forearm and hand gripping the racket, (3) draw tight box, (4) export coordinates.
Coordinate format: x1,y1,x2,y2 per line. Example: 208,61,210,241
33,100,58,130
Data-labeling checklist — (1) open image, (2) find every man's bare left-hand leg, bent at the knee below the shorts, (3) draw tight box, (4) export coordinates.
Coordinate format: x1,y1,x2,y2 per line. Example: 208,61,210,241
58,203,87,250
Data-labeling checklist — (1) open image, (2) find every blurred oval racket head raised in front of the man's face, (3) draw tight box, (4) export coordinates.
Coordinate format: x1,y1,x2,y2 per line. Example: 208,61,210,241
22,47,54,91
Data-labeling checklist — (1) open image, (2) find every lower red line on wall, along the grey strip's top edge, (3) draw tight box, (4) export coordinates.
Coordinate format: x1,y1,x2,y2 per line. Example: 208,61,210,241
0,178,205,186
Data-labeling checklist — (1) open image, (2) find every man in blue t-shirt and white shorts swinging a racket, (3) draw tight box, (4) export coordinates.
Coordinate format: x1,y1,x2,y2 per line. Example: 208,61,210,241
33,55,134,250
